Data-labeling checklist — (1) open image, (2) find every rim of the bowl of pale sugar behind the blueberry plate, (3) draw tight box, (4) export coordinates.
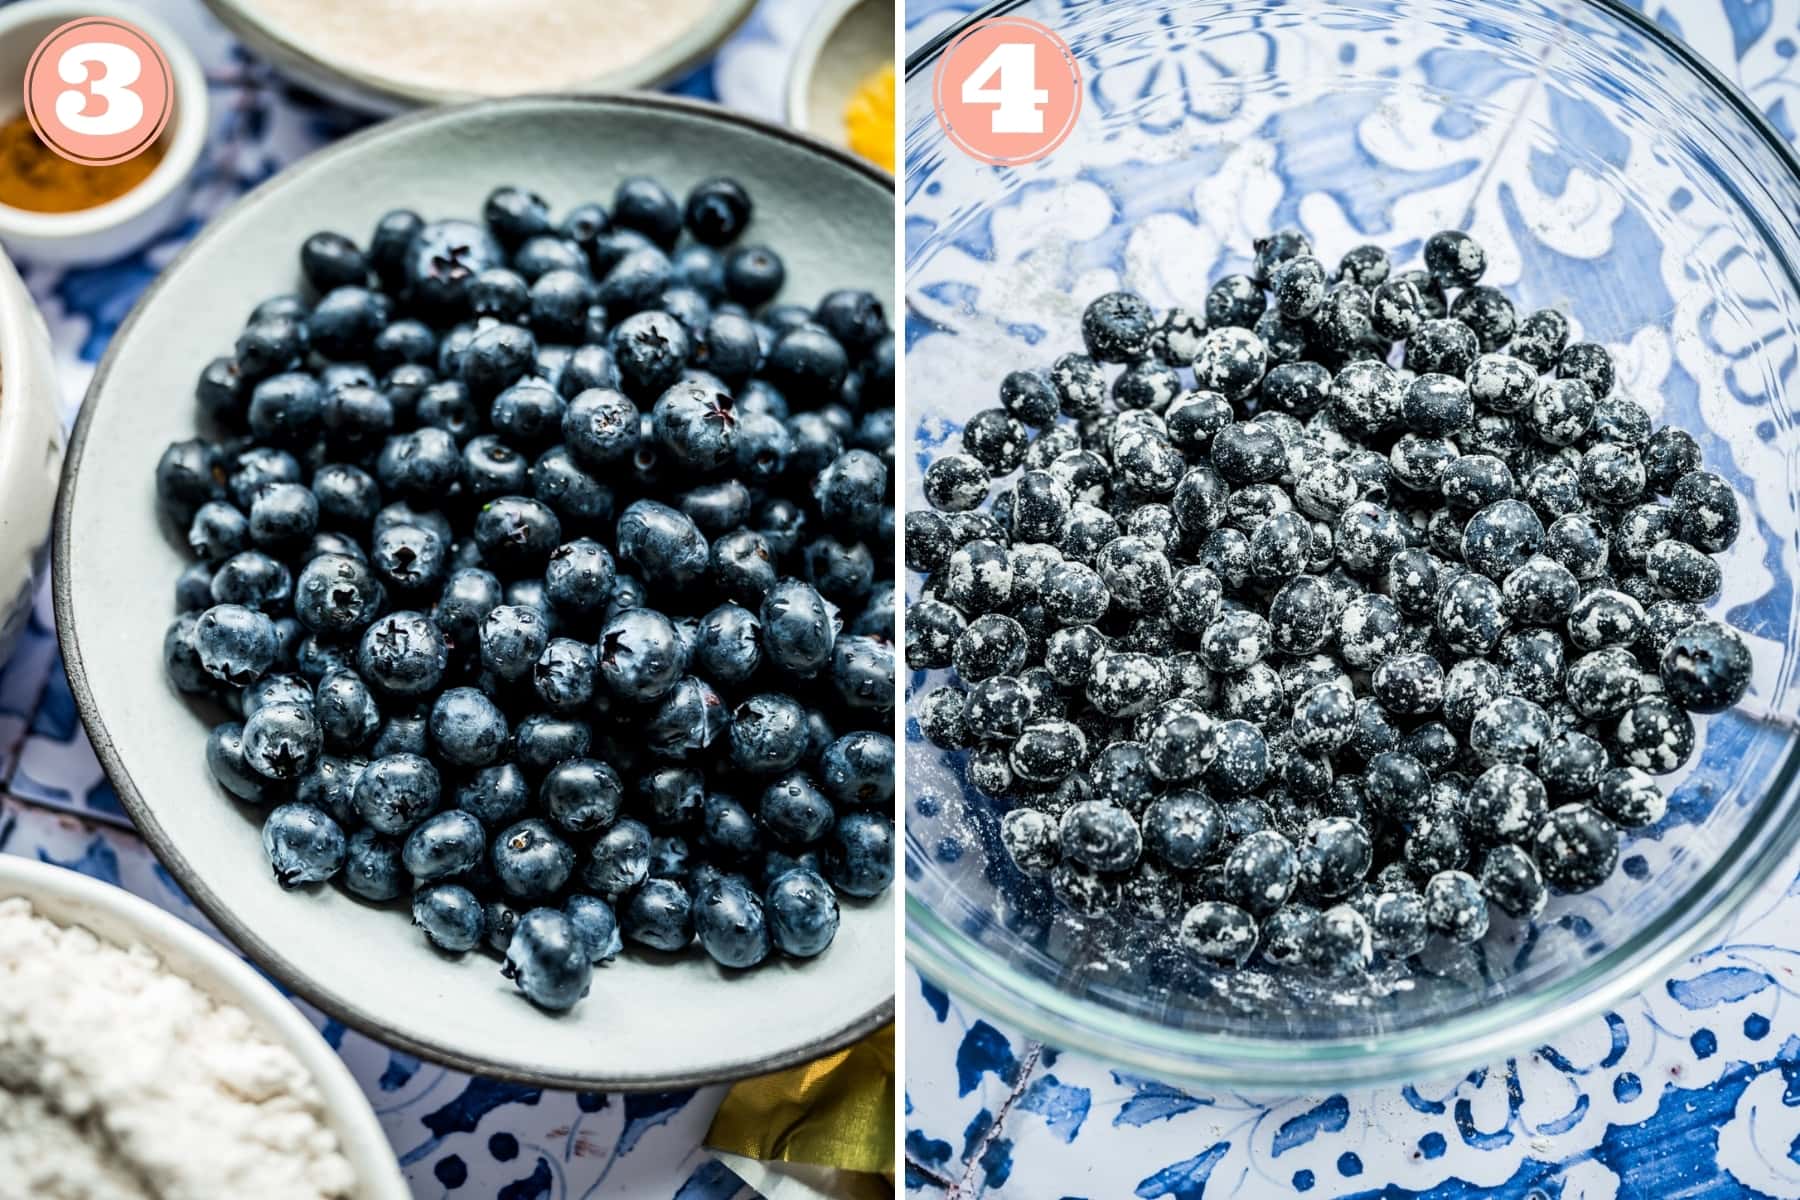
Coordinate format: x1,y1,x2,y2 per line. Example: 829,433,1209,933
207,0,756,110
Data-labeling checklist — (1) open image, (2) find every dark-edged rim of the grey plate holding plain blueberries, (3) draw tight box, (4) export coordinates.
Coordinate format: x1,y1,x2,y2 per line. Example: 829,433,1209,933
50,92,898,1092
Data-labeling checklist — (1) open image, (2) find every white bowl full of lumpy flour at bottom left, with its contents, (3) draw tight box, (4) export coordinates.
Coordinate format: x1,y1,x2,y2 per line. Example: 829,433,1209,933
0,855,409,1200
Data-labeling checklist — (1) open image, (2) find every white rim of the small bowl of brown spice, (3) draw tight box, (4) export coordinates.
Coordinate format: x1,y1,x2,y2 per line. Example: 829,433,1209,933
0,0,209,241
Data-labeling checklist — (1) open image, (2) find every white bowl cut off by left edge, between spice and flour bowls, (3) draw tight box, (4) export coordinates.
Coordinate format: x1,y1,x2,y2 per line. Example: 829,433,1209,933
0,239,63,662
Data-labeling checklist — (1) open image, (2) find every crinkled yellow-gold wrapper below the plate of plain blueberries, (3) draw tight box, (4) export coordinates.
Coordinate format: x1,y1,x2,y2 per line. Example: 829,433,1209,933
706,1024,895,1182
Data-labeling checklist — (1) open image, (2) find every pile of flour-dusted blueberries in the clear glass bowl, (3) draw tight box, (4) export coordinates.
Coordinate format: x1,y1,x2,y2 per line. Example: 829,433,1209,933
905,230,1751,979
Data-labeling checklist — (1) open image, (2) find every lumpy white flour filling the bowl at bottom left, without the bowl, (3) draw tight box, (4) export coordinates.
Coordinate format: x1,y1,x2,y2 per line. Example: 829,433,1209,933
0,900,355,1200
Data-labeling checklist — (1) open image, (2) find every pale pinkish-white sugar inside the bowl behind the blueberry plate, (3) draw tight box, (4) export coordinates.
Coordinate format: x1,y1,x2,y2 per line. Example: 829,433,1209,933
243,0,715,95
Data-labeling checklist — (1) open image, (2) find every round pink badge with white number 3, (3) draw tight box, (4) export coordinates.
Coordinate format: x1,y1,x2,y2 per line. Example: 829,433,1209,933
25,16,175,166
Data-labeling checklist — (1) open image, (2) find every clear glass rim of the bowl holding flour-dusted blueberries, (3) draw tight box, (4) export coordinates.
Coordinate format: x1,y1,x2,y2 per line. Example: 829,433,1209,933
904,0,1800,1092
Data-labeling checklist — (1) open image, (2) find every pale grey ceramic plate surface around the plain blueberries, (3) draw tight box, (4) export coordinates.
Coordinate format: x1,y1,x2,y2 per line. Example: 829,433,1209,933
54,95,895,1088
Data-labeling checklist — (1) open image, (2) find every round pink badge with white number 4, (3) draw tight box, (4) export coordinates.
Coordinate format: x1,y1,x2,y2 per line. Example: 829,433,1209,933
931,16,1082,167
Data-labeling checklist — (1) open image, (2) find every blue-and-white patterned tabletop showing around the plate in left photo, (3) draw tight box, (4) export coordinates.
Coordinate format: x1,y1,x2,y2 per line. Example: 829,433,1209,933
0,0,817,1200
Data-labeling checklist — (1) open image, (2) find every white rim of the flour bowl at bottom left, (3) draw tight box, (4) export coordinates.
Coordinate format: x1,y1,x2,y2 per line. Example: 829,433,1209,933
0,855,412,1200
